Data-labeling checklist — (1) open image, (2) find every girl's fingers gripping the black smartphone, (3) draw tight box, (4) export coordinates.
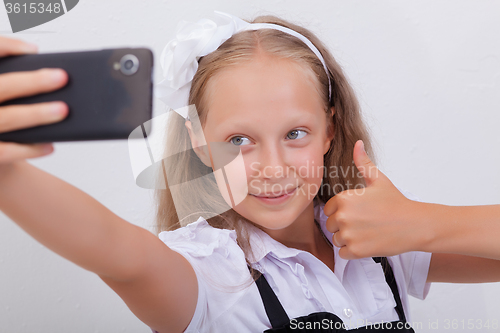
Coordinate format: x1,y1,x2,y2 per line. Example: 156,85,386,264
0,36,68,165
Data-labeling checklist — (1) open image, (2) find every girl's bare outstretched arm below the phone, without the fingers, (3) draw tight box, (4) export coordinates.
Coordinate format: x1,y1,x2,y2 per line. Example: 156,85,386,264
0,161,198,333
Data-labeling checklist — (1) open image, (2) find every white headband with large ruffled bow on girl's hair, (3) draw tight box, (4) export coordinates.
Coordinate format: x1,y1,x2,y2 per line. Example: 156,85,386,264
155,11,332,119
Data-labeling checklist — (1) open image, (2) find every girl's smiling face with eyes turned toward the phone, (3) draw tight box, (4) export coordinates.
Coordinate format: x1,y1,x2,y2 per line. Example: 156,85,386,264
188,53,332,230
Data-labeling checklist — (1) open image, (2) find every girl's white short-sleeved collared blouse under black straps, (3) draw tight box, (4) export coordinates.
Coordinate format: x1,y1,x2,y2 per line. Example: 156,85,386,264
159,198,431,333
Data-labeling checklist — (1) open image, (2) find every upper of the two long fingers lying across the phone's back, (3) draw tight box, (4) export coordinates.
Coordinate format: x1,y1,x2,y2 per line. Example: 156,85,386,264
0,68,68,103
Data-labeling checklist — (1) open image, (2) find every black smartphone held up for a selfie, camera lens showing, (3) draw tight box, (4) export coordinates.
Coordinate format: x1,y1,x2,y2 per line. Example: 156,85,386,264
0,48,153,143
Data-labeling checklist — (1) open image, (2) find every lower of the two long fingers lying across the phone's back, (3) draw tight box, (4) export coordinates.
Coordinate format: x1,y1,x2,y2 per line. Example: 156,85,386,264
0,102,68,133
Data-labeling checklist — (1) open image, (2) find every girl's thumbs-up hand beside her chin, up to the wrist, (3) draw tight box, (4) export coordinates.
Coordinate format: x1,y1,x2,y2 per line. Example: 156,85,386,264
324,140,426,259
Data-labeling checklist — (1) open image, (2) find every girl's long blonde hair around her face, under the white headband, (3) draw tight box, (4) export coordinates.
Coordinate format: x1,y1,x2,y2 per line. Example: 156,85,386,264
155,15,374,278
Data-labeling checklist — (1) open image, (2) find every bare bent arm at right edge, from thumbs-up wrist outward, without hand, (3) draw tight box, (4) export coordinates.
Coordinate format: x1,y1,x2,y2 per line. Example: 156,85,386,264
416,202,500,283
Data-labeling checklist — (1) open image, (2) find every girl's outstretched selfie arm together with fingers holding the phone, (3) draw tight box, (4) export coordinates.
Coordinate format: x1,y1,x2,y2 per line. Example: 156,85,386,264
0,36,197,333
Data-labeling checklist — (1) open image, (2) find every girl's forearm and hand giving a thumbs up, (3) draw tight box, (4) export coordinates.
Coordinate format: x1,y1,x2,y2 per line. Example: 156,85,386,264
324,141,500,259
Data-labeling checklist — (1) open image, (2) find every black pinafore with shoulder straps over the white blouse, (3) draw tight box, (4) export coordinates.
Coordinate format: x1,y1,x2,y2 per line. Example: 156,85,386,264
255,257,415,333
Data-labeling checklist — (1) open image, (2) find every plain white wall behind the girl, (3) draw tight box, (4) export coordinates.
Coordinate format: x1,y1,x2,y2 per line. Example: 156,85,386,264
0,0,500,332
